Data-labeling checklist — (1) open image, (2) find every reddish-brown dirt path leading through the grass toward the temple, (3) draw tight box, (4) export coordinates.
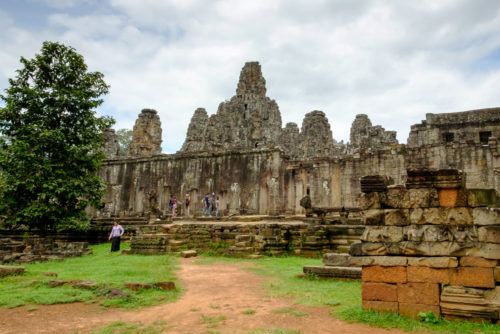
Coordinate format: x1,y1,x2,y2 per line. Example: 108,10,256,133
0,259,402,334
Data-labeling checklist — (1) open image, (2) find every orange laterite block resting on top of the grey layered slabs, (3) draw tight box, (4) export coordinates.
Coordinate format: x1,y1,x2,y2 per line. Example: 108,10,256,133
450,267,495,288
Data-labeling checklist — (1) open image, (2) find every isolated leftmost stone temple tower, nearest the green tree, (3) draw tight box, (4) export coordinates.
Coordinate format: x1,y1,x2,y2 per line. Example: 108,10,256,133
128,109,161,156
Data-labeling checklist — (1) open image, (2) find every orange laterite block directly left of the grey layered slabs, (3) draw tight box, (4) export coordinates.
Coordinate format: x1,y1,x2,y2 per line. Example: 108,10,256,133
397,283,440,305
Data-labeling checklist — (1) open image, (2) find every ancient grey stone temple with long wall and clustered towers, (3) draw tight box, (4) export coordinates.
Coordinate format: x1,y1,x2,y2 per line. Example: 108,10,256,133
93,62,500,217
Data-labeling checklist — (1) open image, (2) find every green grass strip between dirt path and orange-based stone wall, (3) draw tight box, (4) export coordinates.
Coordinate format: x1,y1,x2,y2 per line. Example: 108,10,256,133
199,257,500,334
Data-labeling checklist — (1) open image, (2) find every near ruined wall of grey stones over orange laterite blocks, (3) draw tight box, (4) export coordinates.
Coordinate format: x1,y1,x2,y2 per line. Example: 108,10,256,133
350,169,500,321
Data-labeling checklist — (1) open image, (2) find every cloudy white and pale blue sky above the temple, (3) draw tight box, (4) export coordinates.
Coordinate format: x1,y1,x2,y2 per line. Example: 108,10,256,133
0,0,500,153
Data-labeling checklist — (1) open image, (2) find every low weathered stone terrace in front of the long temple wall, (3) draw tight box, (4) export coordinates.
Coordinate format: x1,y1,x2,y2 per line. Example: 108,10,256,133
131,217,363,257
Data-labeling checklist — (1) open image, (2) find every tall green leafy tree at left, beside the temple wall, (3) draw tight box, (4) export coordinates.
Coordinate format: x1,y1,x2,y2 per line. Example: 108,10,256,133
0,42,114,230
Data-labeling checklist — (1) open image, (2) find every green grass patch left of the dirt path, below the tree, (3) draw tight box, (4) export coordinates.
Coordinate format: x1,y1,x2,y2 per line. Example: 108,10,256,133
0,243,180,308
